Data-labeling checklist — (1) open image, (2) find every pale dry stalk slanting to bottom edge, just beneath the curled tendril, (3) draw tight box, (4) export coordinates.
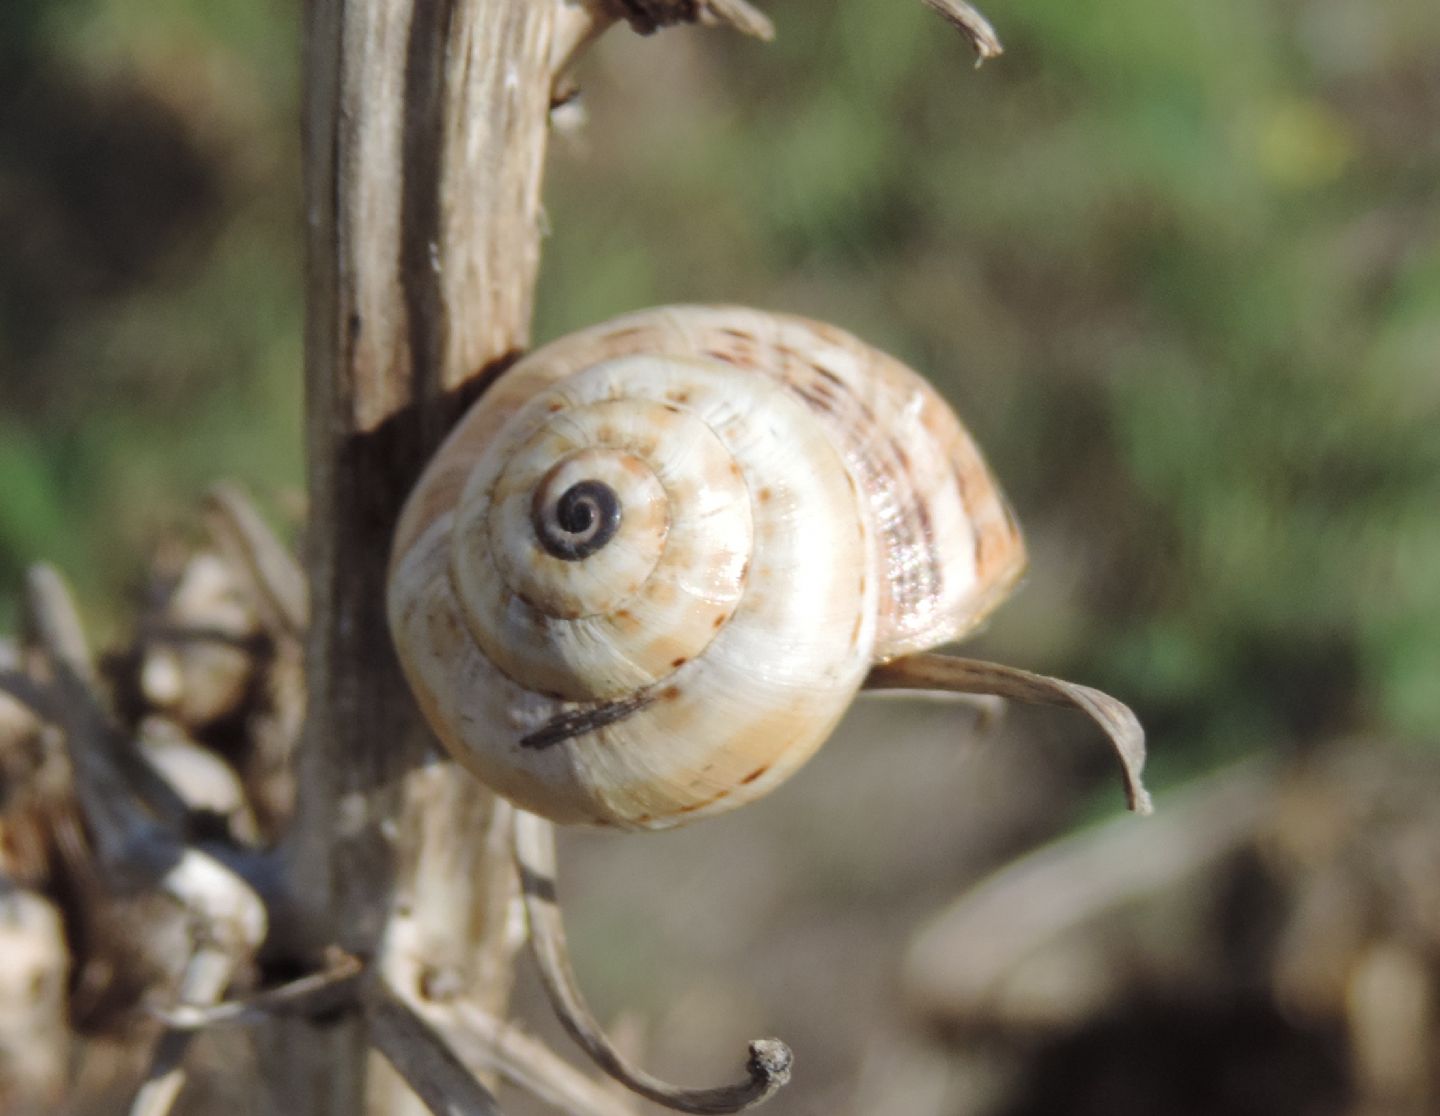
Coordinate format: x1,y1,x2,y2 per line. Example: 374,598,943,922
396,991,635,1116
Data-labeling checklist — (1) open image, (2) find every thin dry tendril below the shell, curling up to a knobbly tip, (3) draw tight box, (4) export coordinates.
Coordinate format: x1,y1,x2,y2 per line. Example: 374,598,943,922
516,811,792,1113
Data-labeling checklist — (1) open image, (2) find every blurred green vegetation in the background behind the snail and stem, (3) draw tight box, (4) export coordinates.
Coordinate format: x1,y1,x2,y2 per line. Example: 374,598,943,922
0,0,1440,770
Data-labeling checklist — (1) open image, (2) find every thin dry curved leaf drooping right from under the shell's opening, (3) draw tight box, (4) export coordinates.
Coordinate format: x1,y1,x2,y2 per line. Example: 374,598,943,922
865,652,1153,814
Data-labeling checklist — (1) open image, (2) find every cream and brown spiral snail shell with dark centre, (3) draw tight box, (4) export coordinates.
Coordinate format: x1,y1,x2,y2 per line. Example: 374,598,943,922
389,307,1025,829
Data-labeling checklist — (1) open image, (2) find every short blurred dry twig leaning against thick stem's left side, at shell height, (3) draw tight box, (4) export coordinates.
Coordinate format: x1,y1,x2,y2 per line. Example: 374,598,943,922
204,484,310,641
